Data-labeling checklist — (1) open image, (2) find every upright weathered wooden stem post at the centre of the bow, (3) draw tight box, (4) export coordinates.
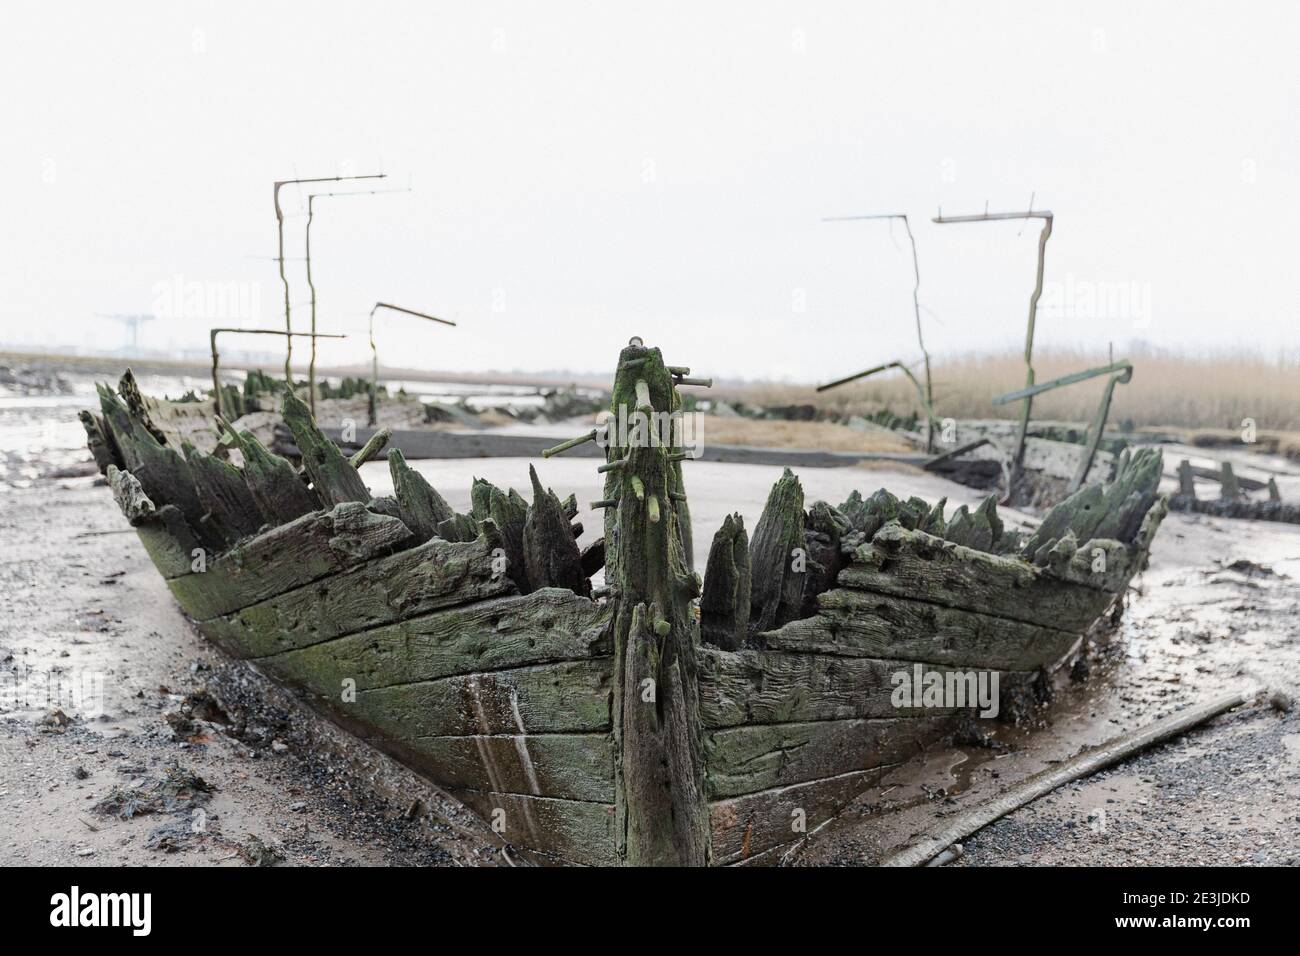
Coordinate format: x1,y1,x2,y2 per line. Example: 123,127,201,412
605,339,712,866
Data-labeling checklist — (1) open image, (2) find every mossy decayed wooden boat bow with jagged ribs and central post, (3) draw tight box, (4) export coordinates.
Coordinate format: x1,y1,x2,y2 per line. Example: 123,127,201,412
82,339,1165,865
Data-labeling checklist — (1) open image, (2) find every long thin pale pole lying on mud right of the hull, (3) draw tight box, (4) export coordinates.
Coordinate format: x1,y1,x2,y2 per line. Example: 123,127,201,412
880,692,1255,866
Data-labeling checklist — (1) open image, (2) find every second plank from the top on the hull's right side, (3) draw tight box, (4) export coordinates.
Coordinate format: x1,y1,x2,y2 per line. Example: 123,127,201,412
759,588,1079,671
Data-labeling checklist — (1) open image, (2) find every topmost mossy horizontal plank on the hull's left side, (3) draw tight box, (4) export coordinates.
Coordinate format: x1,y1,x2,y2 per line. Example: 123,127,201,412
168,502,411,620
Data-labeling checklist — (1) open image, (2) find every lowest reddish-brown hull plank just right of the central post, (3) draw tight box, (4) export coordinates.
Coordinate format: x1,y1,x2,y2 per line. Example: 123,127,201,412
709,769,881,865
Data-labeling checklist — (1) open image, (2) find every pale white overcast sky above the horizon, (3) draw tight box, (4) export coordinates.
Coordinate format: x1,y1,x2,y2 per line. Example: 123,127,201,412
0,0,1300,380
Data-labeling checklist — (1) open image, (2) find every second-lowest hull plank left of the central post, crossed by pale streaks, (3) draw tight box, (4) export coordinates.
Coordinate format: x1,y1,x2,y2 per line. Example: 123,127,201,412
397,734,614,804
